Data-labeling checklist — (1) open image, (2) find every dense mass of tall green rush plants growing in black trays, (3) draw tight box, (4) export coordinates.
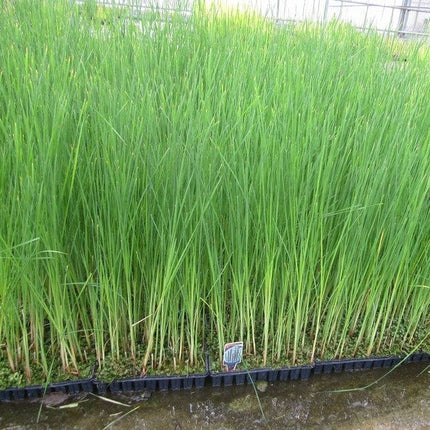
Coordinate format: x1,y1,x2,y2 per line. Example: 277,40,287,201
0,0,430,386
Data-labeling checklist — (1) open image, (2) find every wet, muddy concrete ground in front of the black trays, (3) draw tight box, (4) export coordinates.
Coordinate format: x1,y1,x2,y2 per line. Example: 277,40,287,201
0,363,430,430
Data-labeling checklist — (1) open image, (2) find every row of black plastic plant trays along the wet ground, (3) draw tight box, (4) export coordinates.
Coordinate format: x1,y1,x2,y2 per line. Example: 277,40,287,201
0,352,430,401
